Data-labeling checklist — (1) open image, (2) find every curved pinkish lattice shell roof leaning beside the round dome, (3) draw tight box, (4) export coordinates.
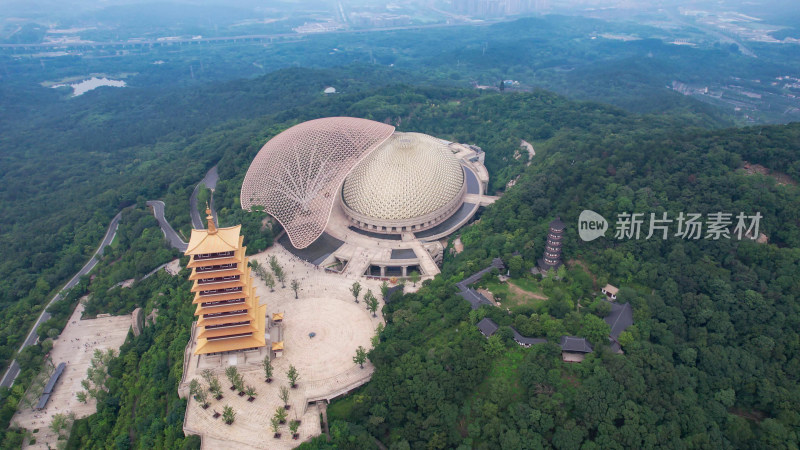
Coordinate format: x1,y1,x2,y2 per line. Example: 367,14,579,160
240,117,394,248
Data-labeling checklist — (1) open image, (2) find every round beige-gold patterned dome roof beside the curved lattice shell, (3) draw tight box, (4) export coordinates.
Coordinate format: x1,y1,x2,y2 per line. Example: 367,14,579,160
342,132,464,220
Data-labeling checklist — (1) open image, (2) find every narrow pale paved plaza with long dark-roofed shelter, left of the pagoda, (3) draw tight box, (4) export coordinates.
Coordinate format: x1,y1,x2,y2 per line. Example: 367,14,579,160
11,304,131,449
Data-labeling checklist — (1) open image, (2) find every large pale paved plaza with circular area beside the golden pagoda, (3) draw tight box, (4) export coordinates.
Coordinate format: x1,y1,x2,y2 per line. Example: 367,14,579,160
182,245,383,450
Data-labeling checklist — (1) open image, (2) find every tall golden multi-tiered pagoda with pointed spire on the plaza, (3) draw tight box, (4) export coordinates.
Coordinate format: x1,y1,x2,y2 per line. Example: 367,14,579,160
186,205,267,355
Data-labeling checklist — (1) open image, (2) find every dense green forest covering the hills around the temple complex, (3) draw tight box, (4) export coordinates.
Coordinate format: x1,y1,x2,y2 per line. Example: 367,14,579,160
0,58,800,448
